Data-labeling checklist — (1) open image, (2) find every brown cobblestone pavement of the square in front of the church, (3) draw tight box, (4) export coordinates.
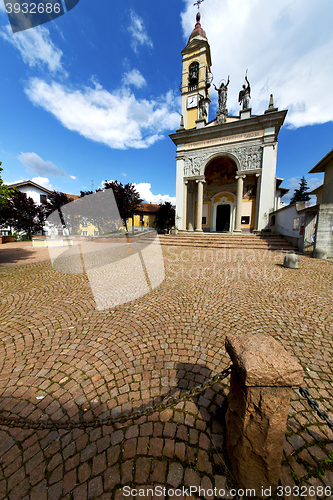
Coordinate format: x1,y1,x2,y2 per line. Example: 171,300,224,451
0,247,333,500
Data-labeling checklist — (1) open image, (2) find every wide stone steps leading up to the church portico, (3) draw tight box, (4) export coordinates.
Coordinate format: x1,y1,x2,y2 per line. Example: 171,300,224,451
159,233,298,252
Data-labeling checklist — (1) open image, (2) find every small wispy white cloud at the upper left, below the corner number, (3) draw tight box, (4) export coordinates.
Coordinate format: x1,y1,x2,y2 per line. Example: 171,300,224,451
0,25,62,72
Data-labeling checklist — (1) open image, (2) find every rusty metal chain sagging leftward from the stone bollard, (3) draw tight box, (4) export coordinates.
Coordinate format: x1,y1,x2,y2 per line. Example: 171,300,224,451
0,365,233,431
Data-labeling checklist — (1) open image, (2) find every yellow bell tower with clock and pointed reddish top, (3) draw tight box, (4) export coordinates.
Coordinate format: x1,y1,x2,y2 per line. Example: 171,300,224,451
181,12,212,129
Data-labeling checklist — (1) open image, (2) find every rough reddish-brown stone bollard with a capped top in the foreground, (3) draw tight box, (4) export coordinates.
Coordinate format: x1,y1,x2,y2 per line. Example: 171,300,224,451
225,333,303,498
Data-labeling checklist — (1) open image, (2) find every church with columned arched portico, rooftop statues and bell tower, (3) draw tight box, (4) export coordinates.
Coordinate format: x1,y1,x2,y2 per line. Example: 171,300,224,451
170,12,288,233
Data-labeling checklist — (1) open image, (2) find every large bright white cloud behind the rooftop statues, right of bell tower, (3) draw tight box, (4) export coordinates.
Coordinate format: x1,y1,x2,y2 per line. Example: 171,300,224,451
182,0,333,127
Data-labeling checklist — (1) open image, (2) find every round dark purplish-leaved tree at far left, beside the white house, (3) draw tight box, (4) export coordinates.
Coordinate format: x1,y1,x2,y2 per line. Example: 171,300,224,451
1,191,44,239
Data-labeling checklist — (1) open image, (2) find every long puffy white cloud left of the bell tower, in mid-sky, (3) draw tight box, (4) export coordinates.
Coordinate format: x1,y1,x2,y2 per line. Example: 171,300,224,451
25,78,179,149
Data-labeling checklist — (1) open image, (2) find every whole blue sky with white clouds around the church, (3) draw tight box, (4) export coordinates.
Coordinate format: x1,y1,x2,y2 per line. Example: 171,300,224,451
0,0,333,203
